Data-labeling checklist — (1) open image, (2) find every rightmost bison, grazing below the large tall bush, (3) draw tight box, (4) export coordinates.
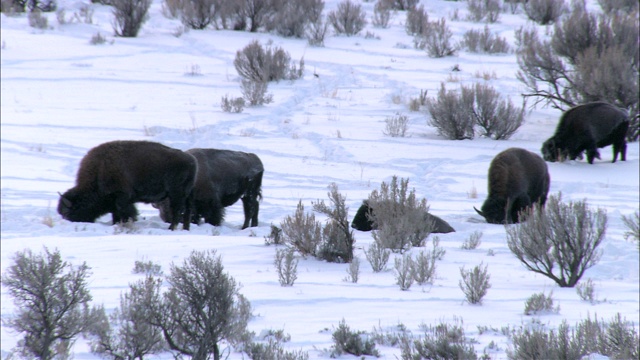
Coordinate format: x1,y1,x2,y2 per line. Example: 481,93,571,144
542,102,629,164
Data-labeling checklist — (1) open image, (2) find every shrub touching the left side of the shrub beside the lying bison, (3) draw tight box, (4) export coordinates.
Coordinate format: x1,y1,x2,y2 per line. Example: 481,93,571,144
280,200,322,256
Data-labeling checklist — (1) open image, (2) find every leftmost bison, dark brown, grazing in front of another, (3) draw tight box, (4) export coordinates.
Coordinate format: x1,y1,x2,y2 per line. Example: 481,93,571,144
58,141,198,230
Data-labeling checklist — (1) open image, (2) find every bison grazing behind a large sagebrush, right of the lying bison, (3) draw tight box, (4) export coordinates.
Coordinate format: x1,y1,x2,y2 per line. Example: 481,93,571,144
474,148,550,224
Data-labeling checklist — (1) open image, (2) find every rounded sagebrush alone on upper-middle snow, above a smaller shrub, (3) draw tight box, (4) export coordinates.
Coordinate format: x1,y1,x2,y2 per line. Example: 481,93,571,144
233,40,304,83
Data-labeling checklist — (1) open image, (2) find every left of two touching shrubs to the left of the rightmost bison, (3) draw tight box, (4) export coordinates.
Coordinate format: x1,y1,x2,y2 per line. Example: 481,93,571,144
427,83,475,140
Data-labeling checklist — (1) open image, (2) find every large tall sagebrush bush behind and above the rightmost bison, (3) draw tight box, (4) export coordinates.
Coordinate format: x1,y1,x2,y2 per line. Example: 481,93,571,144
516,2,640,116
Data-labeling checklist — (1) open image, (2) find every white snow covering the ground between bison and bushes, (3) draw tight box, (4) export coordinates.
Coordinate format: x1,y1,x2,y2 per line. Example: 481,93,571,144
0,0,640,359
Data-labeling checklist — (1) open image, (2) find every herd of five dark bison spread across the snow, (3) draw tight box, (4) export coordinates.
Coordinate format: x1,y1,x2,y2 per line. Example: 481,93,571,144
58,102,629,233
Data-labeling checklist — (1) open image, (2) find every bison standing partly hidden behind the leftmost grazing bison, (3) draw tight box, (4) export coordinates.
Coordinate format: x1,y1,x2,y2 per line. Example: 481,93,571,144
154,149,264,229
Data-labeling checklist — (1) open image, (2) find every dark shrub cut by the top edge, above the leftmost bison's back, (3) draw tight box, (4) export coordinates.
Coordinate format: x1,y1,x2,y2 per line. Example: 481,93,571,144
111,0,151,37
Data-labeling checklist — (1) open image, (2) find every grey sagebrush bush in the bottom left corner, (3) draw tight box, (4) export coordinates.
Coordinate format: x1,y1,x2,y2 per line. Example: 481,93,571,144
2,247,101,360
